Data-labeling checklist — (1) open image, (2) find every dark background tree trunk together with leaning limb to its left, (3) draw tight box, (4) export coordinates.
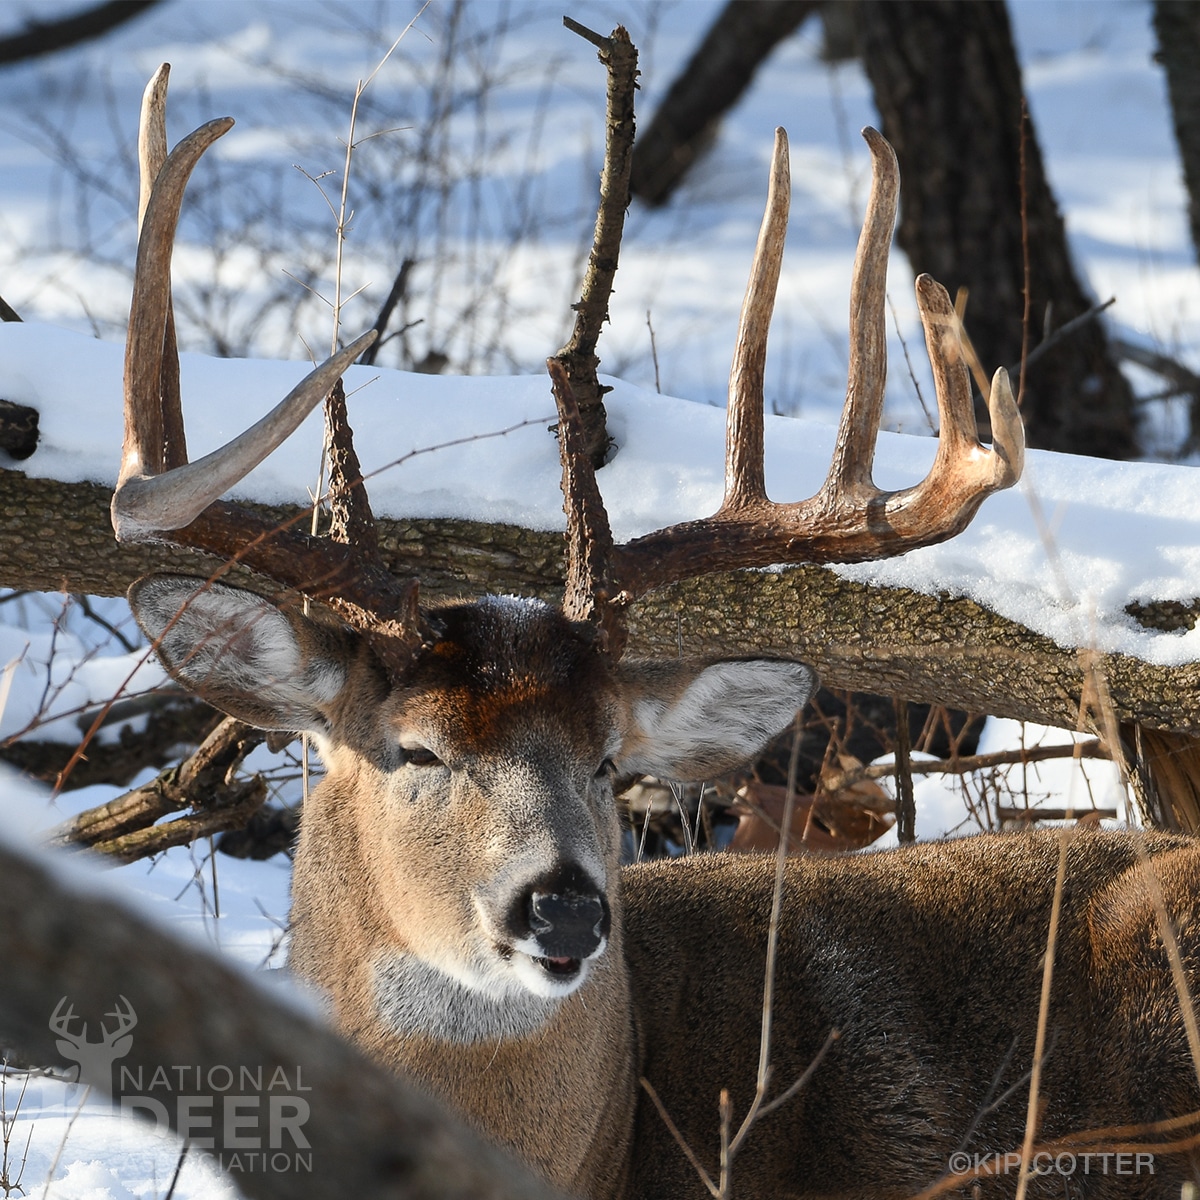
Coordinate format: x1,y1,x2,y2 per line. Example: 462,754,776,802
632,0,1138,458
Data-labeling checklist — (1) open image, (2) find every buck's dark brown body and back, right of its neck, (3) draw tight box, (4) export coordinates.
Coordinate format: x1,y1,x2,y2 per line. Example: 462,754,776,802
625,829,1200,1196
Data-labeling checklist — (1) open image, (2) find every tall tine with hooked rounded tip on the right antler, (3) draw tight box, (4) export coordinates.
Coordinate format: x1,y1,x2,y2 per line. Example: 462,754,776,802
822,126,900,496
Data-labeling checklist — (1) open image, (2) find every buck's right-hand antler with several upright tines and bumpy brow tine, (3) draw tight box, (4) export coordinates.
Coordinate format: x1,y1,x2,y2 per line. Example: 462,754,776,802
556,128,1025,618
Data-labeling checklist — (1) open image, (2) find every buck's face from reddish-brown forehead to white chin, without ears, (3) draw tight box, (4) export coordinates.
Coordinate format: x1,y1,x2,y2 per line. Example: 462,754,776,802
357,596,619,998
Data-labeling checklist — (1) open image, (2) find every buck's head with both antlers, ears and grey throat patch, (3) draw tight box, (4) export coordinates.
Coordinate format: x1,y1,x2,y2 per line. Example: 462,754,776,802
113,68,1022,1042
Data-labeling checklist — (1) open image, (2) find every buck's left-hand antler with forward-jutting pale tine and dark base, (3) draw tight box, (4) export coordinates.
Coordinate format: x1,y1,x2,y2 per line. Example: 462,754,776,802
112,65,428,674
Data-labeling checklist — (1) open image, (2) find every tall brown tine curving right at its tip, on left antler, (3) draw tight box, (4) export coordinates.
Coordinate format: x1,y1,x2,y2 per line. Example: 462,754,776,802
118,116,233,492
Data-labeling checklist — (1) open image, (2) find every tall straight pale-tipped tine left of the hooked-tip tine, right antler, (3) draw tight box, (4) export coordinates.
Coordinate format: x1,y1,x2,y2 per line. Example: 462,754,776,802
721,128,792,512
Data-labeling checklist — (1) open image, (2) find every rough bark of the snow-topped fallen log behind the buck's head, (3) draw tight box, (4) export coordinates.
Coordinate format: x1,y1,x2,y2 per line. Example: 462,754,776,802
0,470,1200,733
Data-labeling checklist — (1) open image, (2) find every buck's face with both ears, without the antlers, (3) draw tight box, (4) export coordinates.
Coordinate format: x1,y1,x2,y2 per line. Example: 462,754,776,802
131,577,814,1014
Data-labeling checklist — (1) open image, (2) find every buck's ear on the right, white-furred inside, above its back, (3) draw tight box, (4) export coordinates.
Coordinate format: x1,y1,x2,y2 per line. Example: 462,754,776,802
617,659,817,781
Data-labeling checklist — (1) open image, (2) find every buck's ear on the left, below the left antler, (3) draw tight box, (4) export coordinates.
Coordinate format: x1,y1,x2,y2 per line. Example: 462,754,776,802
128,575,350,733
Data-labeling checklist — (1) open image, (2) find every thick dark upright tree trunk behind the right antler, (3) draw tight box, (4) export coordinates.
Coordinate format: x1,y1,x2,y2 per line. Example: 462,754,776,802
859,0,1136,458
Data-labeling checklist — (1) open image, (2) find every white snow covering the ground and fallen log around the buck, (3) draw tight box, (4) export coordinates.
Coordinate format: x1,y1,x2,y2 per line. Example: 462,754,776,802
0,0,1200,1200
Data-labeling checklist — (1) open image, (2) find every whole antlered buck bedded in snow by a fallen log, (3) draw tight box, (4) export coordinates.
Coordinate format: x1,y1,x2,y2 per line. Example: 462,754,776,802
113,65,1200,1200
